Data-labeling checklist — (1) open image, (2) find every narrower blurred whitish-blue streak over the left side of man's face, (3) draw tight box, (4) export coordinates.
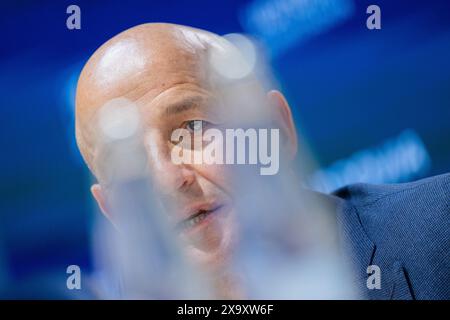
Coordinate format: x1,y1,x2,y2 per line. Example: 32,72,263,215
93,99,213,299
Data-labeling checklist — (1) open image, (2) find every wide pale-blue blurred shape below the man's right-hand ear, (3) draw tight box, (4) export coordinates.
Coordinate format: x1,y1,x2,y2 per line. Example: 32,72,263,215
235,164,357,299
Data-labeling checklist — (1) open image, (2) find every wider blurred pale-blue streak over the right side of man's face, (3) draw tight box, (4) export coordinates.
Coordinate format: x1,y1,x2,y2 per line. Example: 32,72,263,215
212,33,357,299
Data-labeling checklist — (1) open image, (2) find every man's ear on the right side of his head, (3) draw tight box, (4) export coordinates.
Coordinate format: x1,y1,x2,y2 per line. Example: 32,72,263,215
267,90,298,160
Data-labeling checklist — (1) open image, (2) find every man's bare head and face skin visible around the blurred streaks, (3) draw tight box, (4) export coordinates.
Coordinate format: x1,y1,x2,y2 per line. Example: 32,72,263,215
76,24,297,297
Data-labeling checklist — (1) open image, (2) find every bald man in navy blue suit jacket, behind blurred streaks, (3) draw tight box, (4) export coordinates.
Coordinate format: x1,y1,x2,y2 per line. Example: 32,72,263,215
76,24,450,299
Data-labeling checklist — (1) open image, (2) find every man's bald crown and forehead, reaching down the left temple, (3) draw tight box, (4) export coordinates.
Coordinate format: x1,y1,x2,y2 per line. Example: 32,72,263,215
76,23,229,176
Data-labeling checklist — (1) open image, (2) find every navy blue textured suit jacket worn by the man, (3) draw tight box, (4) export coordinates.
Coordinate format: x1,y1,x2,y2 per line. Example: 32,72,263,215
332,174,450,299
